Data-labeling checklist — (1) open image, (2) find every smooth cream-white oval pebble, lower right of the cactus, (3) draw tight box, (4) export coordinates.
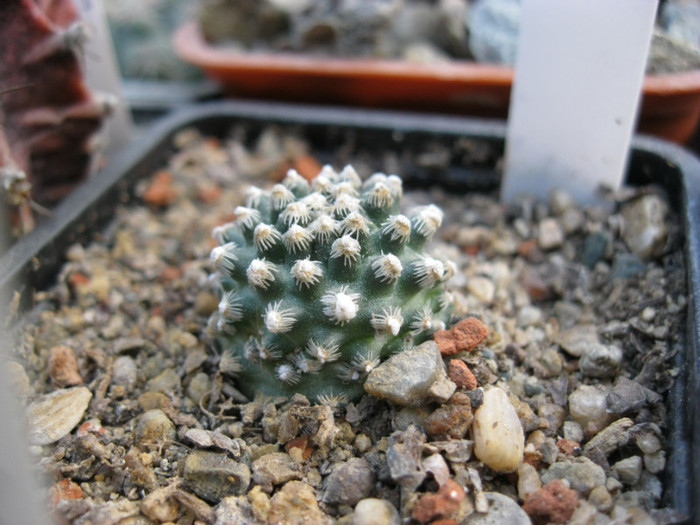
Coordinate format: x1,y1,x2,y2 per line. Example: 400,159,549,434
472,387,525,472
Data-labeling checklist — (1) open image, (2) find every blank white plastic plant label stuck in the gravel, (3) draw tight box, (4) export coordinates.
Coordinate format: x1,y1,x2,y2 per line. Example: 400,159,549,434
501,0,658,204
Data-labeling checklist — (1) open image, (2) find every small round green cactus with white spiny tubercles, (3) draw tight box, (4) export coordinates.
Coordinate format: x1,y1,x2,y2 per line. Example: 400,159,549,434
211,166,454,401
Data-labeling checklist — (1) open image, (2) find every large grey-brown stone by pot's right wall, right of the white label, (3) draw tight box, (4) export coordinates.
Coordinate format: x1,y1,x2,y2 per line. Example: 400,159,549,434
621,194,668,259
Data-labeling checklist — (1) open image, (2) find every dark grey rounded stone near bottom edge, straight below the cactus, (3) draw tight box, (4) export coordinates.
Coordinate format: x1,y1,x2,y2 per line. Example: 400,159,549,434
323,458,375,506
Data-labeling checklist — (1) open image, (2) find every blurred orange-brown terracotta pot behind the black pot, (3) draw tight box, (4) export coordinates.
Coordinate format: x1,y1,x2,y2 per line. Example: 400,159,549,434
174,22,700,143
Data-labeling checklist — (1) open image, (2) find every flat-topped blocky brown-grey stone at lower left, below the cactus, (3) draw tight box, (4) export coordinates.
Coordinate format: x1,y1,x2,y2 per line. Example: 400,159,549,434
182,450,250,503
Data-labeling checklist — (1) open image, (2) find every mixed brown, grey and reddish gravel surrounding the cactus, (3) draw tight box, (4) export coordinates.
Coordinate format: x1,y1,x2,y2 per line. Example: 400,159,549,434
3,126,687,525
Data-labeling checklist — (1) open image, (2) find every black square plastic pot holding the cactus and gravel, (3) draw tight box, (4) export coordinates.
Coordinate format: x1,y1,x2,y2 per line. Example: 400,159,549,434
0,102,700,523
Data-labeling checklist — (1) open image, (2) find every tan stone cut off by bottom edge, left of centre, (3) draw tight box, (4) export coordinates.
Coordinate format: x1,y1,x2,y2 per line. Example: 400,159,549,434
267,481,333,525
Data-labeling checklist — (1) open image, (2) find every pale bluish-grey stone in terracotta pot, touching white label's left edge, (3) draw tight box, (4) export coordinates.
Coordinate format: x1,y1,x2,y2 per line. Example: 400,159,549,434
467,0,521,66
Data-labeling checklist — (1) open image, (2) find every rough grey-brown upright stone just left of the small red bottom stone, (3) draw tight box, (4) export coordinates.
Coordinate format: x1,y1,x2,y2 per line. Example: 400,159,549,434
386,426,425,490
